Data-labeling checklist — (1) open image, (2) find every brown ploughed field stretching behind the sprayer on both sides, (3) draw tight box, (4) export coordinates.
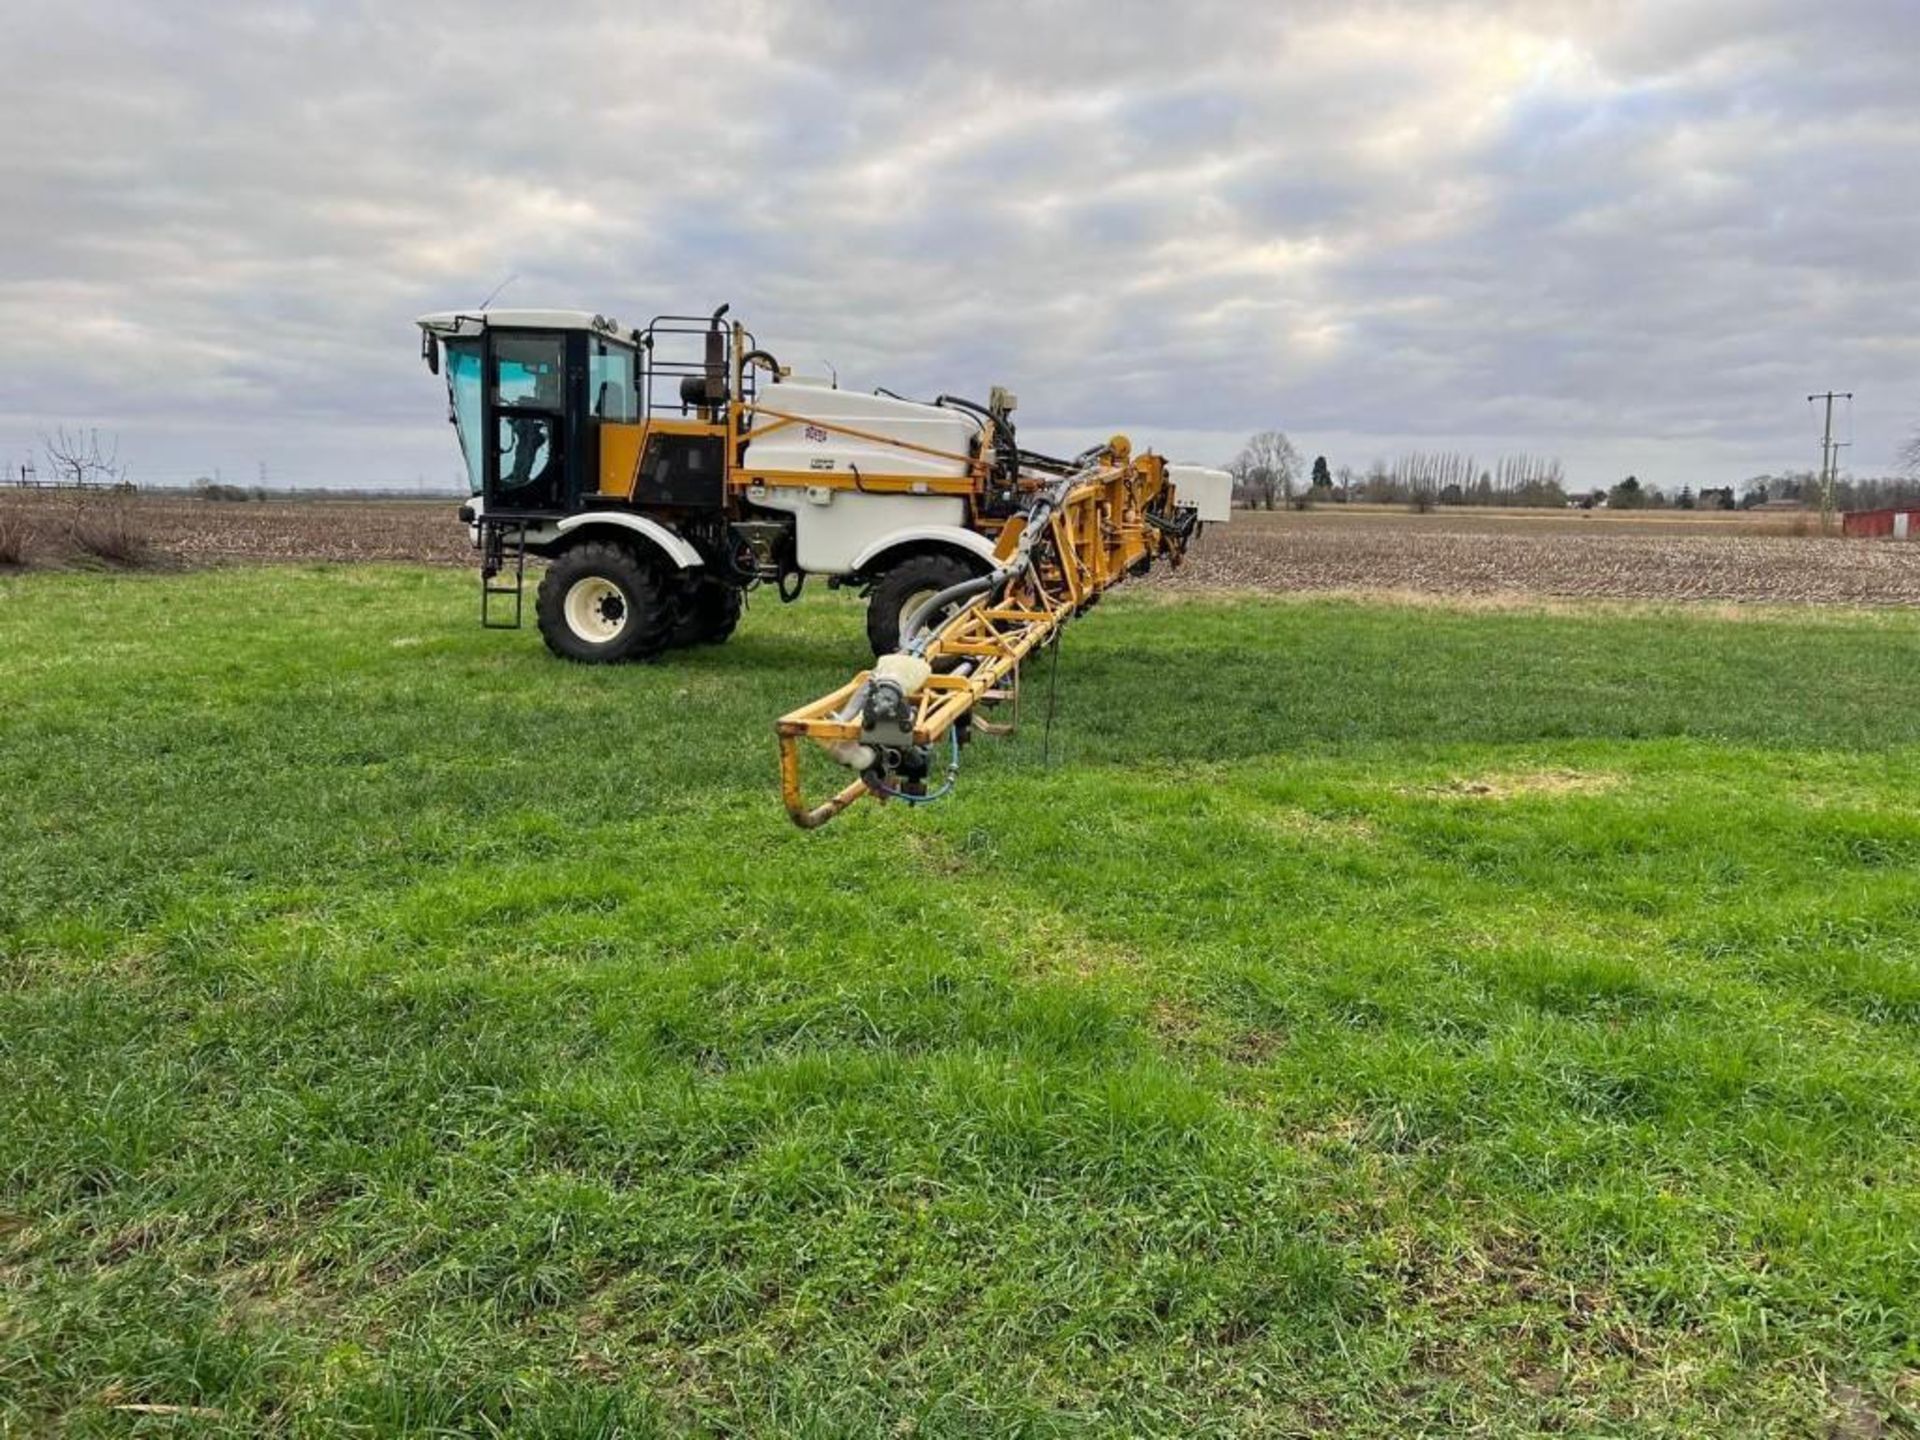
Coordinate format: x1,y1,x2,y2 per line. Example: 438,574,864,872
11,490,1920,605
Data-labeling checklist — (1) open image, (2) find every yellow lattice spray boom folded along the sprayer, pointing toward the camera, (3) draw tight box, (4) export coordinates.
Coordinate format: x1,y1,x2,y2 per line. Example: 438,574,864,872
776,436,1198,829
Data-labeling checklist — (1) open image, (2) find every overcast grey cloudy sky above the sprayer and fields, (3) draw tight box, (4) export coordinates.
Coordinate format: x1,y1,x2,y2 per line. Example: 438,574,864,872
0,0,1920,486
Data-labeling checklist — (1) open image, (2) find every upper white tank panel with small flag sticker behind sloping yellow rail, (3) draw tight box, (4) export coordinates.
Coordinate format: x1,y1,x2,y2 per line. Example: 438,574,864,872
747,380,979,476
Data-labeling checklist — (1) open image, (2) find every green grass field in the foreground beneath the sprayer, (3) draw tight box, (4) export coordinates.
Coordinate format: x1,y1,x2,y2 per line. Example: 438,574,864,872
0,568,1920,1436
